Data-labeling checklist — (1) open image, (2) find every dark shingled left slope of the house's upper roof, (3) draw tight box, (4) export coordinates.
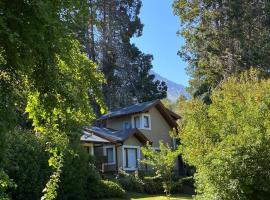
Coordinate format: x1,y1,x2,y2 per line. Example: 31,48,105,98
98,100,159,120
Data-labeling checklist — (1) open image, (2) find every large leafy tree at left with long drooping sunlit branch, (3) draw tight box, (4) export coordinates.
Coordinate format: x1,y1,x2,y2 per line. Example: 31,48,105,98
0,0,103,199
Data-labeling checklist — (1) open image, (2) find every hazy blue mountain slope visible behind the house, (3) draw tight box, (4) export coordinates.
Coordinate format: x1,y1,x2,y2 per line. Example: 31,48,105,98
150,71,190,102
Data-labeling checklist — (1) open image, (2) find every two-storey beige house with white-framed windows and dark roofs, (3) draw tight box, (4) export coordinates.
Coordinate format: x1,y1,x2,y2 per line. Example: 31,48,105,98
81,100,180,172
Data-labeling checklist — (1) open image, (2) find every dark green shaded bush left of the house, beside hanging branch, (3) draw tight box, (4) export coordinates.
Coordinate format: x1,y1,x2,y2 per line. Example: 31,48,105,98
57,142,101,200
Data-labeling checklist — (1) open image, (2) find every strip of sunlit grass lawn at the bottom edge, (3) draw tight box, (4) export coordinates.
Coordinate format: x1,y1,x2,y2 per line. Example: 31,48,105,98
101,193,192,200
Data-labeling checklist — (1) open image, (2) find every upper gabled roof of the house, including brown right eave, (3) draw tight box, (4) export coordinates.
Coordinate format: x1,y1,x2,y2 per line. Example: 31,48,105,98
97,100,181,126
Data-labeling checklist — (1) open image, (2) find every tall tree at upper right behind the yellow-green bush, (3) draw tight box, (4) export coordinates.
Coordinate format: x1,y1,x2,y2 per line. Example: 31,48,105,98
173,0,270,103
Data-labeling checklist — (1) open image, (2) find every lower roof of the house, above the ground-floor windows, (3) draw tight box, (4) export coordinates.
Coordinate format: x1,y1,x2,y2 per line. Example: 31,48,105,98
84,126,152,144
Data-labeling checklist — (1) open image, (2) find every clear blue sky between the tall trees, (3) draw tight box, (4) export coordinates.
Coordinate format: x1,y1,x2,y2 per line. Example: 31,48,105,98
132,0,189,86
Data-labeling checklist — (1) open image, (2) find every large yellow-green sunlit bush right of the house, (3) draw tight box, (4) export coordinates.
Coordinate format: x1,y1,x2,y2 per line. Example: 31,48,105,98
180,71,270,200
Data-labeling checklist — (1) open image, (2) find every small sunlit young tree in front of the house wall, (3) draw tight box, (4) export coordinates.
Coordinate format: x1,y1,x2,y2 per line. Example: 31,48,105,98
140,141,180,195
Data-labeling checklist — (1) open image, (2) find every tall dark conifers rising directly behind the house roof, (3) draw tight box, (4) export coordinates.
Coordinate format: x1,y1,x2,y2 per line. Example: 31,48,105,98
74,0,167,111
